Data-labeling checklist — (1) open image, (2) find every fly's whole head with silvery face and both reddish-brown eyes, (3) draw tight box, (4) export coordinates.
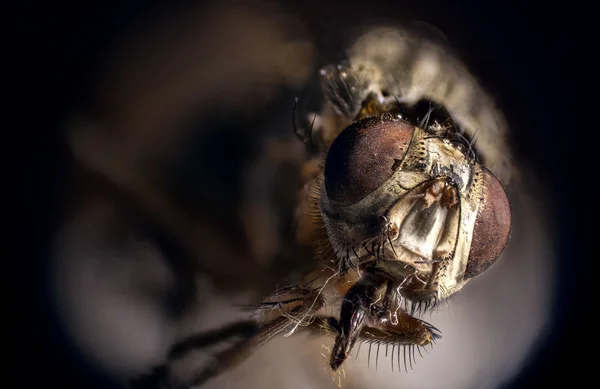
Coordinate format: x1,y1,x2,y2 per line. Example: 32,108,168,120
319,112,511,301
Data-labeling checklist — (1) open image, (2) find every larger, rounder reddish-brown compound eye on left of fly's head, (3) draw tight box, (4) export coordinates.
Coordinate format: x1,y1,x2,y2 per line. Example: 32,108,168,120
325,118,415,206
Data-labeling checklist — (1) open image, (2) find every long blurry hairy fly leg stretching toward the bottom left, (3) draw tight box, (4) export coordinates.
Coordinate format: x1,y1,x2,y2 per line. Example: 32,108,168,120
130,287,325,389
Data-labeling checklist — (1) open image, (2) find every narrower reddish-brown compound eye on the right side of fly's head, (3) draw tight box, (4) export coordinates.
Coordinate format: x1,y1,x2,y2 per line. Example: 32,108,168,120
465,168,512,278
